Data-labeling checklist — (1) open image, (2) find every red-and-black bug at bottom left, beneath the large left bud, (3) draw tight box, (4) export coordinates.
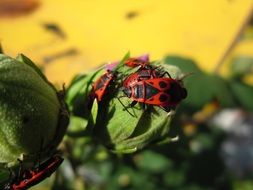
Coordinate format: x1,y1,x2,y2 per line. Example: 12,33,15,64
4,155,63,190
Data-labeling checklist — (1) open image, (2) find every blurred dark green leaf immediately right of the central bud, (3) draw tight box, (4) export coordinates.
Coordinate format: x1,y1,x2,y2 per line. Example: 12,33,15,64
164,56,235,111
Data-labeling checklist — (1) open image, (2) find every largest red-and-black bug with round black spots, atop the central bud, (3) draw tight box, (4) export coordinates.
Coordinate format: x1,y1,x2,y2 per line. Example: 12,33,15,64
119,78,187,112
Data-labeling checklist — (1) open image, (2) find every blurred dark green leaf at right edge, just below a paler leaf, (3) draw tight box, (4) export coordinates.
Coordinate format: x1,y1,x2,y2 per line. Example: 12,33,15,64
229,80,253,111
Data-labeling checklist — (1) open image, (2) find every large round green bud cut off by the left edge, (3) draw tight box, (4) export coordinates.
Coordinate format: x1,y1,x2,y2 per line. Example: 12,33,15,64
0,54,68,167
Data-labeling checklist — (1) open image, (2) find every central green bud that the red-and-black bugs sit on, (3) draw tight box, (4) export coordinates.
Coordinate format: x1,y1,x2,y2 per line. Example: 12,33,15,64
94,62,183,153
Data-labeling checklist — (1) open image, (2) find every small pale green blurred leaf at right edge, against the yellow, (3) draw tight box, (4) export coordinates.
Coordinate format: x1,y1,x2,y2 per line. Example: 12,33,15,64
230,56,253,77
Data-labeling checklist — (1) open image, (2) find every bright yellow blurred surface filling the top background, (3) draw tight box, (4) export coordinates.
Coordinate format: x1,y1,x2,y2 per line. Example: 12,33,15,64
0,0,253,84
